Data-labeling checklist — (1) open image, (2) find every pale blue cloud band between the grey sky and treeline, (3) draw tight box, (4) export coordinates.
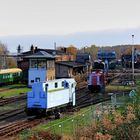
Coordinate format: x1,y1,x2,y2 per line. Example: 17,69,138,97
0,28,140,52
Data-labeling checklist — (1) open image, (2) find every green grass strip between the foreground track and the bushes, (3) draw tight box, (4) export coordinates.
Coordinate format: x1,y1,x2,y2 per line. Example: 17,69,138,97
19,105,95,140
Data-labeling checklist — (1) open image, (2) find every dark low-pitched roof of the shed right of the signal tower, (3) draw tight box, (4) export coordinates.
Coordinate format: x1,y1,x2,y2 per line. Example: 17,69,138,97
56,61,86,68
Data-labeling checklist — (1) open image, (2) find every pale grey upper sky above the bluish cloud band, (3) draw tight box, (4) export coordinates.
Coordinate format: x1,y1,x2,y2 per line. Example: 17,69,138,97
0,0,140,36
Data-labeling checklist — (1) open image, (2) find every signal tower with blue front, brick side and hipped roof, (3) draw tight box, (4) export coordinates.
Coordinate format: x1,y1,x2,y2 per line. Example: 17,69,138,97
26,51,55,86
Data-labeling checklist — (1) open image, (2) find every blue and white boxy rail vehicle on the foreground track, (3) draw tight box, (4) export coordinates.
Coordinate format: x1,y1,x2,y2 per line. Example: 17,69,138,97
26,78,76,116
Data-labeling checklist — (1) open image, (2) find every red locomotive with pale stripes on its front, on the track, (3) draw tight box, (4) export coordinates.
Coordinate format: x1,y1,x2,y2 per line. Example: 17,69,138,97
88,70,106,92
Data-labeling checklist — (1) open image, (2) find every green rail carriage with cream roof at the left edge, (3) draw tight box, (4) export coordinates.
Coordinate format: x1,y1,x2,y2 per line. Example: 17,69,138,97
0,68,22,85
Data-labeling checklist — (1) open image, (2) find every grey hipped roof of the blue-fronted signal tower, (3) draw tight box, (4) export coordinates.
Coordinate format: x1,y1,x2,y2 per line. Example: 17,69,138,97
26,51,55,59
